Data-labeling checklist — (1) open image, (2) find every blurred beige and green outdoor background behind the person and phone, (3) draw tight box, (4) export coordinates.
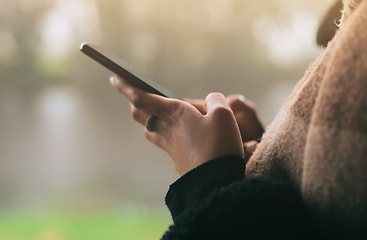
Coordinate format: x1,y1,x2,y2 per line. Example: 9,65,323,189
0,0,333,240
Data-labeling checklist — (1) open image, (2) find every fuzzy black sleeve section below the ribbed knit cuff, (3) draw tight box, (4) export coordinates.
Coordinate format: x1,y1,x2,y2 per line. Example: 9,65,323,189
162,176,320,240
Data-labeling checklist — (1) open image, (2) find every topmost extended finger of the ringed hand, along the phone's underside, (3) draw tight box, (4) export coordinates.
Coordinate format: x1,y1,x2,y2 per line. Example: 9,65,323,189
111,77,171,119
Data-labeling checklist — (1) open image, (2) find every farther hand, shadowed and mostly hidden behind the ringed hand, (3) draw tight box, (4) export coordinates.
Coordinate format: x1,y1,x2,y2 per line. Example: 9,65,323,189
186,95,264,143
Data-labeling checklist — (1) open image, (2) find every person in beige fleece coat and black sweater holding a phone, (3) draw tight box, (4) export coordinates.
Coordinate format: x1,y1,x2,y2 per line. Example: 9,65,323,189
111,0,367,239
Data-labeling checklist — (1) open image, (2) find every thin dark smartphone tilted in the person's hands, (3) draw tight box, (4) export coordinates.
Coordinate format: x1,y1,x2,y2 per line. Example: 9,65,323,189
80,43,177,98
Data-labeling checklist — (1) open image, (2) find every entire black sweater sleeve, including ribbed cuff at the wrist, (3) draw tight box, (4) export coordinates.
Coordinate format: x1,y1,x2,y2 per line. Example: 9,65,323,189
162,156,365,240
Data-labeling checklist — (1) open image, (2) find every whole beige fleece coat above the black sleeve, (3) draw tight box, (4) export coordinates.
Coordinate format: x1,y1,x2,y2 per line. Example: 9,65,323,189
246,0,367,222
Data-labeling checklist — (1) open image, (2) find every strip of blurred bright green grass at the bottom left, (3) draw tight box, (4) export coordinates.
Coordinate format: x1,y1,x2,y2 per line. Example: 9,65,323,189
0,207,171,240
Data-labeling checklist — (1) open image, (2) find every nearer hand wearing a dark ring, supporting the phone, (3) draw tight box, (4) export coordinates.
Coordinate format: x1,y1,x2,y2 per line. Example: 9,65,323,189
111,77,244,175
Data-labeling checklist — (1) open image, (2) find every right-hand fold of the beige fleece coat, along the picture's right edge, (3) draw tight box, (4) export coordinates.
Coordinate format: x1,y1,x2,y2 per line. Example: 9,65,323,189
302,1,367,232
